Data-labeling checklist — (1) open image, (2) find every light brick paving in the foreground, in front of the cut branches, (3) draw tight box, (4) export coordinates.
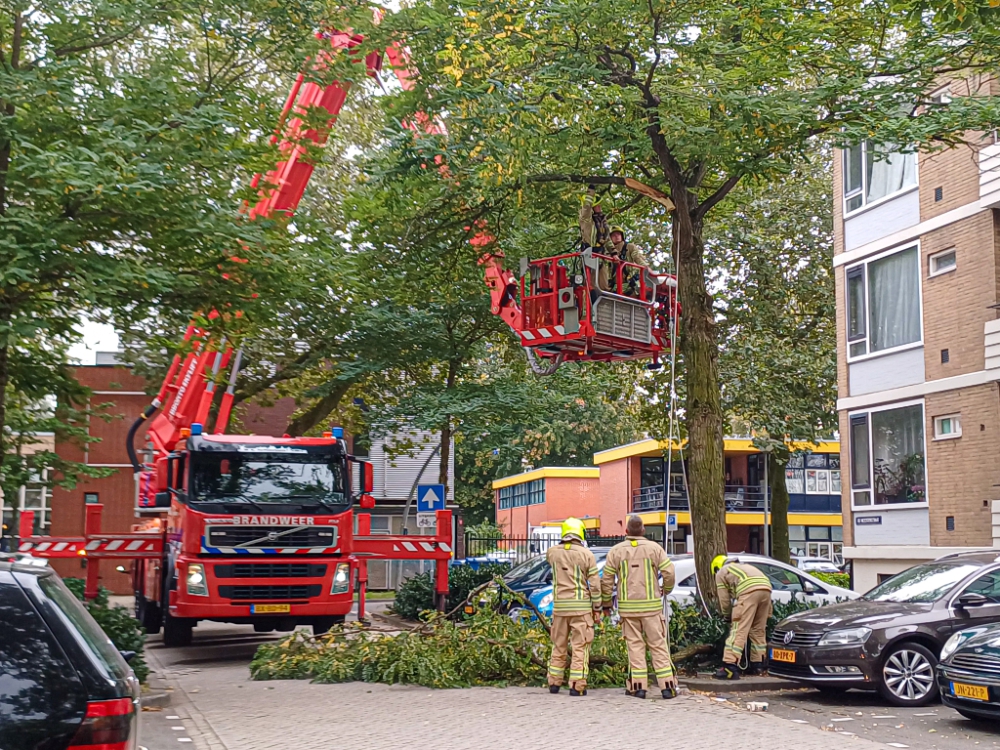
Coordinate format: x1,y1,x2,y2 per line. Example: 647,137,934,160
154,656,900,750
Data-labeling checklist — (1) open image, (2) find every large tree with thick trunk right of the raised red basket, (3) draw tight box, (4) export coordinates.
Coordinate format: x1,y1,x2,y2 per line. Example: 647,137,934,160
338,0,1000,600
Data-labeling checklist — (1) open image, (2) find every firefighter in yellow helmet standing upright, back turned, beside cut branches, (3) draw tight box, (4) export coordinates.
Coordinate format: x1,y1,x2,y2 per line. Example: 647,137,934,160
545,518,601,696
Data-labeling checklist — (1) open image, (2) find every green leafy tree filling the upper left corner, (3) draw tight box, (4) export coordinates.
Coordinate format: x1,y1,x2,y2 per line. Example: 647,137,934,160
0,0,344,508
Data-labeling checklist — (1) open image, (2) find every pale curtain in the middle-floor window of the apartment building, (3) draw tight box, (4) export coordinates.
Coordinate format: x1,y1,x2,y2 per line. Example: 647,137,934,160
868,247,920,352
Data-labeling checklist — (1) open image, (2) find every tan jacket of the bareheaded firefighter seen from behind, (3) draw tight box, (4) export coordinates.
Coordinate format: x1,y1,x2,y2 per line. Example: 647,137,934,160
601,536,674,617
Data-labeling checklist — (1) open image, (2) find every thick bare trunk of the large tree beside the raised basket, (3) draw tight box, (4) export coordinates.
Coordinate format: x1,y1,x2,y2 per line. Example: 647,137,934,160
673,209,726,604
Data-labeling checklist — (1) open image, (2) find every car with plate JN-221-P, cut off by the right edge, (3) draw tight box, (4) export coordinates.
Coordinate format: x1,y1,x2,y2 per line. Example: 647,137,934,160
937,623,1000,721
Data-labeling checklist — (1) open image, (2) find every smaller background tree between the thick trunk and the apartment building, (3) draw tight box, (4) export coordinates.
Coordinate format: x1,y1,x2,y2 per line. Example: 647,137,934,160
706,162,837,562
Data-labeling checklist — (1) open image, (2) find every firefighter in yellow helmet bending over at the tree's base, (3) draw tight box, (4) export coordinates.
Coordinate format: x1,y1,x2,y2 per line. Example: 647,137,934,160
712,555,771,680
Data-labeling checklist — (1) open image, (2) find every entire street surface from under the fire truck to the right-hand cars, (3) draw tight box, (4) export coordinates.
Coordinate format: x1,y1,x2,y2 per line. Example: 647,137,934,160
140,623,1000,750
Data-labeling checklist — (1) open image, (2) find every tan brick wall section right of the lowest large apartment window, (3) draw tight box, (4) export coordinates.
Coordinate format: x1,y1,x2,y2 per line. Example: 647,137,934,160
925,383,1000,547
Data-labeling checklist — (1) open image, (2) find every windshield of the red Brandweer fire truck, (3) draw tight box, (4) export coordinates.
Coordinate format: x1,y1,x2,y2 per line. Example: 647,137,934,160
191,453,350,512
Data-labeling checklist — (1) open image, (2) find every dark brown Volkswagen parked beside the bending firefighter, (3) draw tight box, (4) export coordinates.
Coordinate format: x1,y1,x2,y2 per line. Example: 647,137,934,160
768,550,1000,706
